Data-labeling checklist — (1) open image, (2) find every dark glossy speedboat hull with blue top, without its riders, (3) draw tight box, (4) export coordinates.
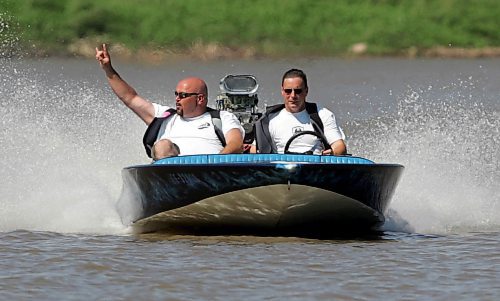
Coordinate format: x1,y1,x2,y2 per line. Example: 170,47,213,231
117,154,404,237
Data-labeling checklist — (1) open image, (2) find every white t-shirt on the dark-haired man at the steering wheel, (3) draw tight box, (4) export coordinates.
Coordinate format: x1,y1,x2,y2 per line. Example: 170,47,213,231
269,106,345,155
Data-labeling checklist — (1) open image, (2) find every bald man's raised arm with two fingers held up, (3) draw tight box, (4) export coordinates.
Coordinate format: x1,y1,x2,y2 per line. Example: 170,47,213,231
95,44,155,125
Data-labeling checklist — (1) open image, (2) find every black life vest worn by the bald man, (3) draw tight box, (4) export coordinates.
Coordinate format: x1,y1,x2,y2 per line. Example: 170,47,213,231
142,108,226,158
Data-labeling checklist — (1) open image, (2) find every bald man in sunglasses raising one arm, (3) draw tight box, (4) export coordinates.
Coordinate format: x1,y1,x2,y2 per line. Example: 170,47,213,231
96,44,245,160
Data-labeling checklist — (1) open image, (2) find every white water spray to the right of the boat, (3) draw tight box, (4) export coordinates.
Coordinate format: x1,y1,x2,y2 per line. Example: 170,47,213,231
360,78,500,234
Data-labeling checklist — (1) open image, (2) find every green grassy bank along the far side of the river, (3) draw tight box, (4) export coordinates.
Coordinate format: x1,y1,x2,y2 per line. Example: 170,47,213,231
0,0,500,55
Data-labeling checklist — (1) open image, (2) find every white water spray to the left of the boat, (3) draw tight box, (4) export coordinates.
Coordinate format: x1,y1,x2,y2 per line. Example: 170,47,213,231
0,56,146,234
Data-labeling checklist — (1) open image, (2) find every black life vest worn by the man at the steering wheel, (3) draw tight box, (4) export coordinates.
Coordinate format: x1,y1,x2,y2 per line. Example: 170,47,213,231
255,102,326,154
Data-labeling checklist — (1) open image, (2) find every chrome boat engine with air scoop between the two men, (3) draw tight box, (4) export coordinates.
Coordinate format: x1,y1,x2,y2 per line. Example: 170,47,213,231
217,75,262,144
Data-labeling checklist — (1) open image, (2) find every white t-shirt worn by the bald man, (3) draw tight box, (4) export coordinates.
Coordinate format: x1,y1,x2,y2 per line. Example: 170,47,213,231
153,103,245,156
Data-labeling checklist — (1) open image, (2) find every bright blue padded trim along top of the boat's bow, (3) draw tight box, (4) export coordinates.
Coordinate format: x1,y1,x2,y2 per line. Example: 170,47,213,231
153,154,373,165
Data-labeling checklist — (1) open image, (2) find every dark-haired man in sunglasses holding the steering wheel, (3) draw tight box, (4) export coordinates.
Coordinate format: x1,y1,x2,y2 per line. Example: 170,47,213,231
251,69,347,155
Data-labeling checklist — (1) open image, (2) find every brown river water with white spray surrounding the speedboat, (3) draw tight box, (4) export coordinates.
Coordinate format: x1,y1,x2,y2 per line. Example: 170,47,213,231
0,58,500,300
